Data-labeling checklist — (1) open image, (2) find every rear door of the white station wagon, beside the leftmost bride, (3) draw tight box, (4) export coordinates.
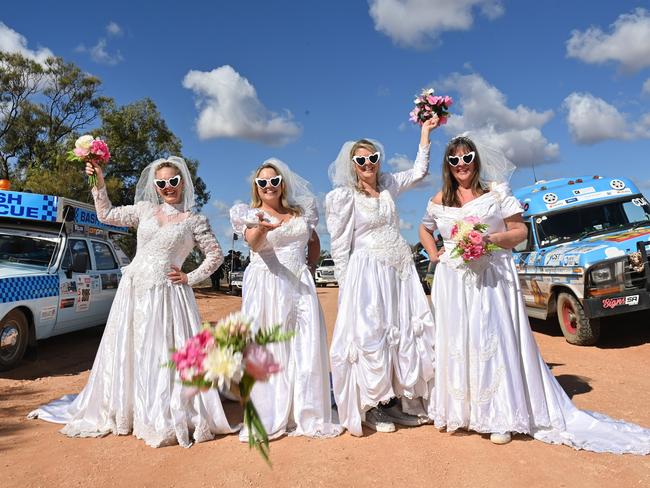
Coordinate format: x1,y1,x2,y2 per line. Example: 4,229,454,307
90,240,122,322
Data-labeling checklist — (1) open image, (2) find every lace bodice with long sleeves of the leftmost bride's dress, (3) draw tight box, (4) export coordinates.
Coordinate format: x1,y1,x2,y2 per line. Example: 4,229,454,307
93,188,223,288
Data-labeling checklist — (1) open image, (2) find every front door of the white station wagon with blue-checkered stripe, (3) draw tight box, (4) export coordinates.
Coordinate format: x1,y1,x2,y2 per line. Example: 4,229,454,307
56,238,98,331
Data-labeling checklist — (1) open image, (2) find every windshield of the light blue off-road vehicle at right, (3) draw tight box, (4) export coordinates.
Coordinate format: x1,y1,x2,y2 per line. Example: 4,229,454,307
534,195,650,247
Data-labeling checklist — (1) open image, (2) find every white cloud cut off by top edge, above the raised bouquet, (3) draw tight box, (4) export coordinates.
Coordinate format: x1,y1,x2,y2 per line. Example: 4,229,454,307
369,0,504,47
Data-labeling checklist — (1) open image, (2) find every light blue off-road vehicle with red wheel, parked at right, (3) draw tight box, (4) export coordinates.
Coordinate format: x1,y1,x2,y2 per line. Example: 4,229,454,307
514,176,650,345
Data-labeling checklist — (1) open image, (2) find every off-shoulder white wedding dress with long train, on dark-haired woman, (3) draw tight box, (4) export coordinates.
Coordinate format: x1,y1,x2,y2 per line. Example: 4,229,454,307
422,183,650,454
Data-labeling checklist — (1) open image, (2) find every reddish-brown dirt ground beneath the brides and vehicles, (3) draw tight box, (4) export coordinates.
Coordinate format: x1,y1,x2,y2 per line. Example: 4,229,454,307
0,289,650,488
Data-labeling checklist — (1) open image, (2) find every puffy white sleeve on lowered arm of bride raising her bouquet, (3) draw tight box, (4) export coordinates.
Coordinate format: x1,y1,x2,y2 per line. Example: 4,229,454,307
325,188,354,289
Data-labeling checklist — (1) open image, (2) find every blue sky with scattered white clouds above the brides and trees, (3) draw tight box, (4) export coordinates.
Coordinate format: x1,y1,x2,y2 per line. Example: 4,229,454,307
0,0,650,252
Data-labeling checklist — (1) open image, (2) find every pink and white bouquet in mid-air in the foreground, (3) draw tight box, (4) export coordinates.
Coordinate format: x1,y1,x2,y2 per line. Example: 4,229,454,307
168,313,293,463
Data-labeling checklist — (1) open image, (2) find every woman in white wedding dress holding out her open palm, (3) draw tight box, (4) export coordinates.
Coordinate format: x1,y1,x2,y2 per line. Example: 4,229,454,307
230,159,341,441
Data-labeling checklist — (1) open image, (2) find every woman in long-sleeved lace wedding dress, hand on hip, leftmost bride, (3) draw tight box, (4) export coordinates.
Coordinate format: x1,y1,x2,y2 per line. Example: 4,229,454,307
29,157,236,447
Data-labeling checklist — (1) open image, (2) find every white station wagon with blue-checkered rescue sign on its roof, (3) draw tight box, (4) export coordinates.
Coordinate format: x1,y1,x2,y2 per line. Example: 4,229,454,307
0,191,129,370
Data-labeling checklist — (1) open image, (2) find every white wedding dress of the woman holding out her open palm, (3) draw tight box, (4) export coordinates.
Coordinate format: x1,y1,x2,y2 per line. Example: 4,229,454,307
230,204,341,440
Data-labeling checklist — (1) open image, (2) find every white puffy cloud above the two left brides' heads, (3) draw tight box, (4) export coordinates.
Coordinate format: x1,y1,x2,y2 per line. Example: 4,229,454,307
183,65,302,146
